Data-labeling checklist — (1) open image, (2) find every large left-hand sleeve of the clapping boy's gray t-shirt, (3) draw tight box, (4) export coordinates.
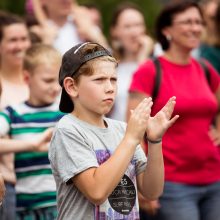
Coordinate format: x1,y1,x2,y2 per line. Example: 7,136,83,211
49,128,98,183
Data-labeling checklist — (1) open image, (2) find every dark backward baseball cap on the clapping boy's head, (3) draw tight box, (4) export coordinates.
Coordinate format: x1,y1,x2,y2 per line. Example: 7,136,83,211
59,42,112,113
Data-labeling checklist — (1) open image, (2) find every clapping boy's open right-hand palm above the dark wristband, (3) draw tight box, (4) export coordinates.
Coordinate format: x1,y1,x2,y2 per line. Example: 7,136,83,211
146,97,179,141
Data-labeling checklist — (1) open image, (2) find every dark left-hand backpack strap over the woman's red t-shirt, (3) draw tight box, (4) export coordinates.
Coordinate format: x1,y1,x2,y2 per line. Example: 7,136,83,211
152,57,161,100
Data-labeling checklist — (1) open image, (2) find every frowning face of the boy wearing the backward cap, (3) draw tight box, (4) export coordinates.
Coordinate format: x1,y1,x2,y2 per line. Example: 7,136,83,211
74,61,117,116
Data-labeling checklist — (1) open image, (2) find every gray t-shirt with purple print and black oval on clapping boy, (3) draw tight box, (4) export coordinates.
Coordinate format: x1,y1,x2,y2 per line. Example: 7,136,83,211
49,114,146,220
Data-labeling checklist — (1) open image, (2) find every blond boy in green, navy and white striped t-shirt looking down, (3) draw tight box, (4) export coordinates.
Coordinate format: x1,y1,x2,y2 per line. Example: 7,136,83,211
0,44,63,219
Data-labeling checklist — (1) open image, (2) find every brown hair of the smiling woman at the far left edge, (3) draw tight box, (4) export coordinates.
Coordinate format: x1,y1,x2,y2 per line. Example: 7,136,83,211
0,11,26,42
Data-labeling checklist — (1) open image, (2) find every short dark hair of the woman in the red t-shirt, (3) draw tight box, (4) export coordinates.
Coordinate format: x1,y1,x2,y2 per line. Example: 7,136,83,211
155,0,203,51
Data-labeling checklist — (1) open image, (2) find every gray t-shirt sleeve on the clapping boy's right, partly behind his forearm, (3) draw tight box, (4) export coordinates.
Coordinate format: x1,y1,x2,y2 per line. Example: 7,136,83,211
134,145,147,176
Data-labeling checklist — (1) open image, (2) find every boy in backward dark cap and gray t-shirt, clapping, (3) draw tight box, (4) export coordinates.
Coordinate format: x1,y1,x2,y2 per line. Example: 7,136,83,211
49,42,178,220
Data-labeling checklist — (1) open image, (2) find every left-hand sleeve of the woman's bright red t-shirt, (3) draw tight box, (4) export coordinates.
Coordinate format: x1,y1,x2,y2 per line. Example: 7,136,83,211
129,60,156,96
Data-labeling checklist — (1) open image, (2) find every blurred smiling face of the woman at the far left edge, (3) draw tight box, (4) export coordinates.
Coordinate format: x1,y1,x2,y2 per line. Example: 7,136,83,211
0,24,30,66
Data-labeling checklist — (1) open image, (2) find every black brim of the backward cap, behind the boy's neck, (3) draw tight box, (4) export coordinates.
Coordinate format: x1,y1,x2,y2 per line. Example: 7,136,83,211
59,88,74,113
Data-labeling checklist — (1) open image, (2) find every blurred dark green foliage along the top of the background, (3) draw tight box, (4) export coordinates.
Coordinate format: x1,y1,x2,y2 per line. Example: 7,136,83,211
0,0,161,35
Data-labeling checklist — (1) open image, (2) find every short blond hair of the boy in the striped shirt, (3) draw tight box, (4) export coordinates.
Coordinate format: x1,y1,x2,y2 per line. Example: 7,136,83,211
24,43,61,73
